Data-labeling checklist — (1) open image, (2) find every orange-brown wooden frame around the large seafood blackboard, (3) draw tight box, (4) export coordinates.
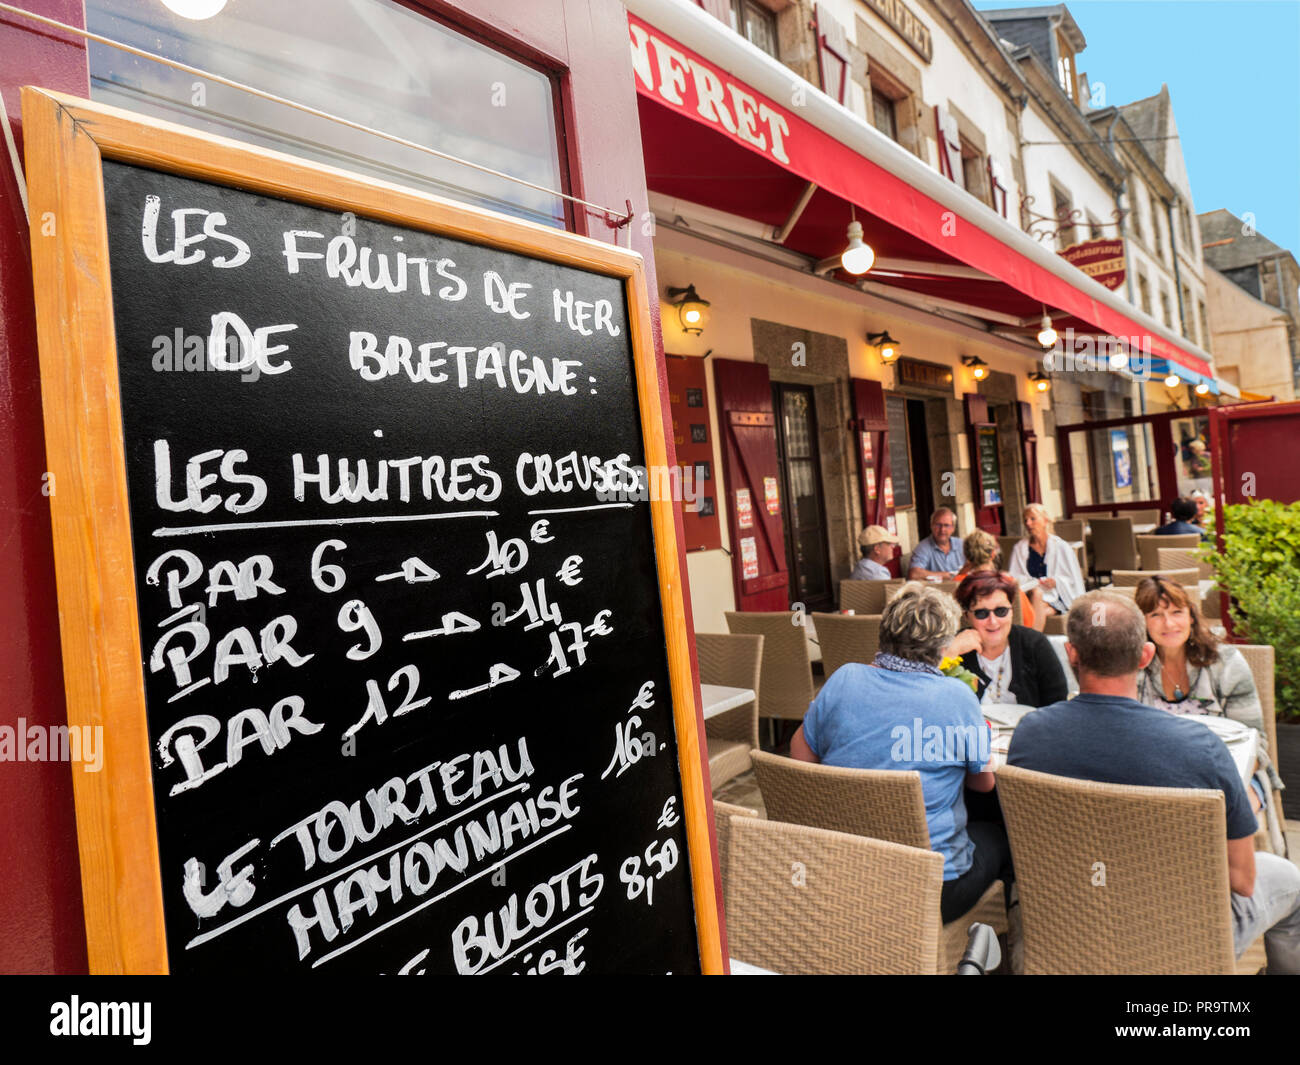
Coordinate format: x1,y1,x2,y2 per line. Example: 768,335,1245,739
22,86,723,974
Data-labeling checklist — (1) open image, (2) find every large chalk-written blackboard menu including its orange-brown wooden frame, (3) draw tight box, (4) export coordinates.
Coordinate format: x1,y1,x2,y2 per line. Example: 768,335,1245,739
23,88,722,979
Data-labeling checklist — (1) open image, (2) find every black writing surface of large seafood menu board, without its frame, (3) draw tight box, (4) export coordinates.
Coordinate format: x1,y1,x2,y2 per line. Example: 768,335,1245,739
104,161,699,978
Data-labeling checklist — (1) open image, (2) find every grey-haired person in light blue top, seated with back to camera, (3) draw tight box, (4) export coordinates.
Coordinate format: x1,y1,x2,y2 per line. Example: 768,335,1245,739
790,581,1013,923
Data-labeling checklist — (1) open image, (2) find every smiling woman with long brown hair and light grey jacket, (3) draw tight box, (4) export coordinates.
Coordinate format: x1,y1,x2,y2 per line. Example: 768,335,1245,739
1135,576,1283,854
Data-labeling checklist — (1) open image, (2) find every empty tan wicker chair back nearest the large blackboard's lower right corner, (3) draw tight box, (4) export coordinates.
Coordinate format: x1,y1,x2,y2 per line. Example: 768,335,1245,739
725,817,944,975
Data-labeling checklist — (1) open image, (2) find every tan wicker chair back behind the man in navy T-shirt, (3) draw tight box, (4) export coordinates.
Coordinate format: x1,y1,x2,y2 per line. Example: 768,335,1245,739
997,766,1235,975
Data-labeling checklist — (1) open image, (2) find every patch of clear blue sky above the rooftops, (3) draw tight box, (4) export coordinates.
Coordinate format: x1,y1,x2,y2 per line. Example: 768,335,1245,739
974,0,1300,257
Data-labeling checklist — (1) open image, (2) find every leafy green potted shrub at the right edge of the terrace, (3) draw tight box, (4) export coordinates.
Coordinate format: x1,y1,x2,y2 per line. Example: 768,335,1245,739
1206,499,1300,818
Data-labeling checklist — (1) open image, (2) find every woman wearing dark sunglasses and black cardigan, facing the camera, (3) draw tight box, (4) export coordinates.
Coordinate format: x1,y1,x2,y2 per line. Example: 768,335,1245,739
948,572,1069,706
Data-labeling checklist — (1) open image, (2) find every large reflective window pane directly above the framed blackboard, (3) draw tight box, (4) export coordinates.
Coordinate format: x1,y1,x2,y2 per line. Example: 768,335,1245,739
86,0,567,226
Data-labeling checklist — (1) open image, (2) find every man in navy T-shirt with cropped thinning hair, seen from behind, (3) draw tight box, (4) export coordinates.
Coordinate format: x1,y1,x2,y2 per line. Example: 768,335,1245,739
1008,592,1300,974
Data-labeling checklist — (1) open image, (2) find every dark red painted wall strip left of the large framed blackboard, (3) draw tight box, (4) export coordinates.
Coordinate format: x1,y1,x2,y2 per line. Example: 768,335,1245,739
0,0,87,973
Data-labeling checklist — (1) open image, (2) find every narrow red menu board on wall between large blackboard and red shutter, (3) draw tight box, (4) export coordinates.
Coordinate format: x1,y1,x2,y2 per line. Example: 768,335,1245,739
666,355,723,551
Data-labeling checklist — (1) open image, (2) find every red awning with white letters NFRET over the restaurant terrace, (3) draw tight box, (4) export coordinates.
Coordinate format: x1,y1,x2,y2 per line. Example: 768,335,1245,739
628,14,1213,375
